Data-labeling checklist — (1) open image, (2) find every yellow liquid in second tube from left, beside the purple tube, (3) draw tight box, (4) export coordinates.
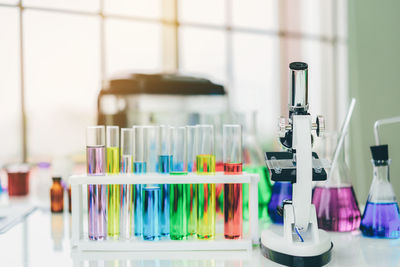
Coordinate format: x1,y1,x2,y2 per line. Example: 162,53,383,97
107,147,121,239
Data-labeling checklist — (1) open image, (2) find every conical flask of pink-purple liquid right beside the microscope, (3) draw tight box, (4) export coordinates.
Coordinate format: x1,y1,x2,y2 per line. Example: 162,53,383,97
312,140,361,232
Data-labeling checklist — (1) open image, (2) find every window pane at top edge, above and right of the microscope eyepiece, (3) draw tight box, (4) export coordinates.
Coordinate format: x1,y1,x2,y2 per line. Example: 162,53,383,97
281,0,334,37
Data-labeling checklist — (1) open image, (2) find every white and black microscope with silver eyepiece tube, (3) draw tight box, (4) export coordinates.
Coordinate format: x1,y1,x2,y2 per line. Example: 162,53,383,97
260,62,333,266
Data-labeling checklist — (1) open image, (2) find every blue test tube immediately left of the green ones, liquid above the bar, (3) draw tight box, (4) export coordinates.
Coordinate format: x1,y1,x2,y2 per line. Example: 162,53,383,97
158,125,172,238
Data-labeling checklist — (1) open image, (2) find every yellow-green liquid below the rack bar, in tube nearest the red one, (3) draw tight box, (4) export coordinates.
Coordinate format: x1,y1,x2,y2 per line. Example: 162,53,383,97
196,184,216,239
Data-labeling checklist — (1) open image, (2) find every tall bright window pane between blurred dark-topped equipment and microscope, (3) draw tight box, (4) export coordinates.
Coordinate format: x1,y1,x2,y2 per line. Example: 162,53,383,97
230,33,280,141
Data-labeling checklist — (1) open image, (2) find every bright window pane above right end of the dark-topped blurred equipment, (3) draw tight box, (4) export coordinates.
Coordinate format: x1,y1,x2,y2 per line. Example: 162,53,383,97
179,27,227,83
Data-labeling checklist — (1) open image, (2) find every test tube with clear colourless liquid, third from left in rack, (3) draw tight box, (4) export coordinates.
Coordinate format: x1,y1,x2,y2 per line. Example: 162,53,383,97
120,128,134,239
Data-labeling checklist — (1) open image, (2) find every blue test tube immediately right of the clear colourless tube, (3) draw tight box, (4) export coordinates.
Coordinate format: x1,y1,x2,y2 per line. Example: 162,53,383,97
131,126,147,237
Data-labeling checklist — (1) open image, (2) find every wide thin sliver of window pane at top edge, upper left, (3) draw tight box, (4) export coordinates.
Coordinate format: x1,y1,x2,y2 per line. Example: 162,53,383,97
23,0,100,11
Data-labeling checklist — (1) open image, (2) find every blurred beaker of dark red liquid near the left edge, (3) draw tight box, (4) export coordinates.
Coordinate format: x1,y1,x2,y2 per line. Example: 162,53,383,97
5,164,30,196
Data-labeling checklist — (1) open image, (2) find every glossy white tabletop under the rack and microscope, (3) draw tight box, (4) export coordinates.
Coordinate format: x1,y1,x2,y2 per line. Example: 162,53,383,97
0,209,400,267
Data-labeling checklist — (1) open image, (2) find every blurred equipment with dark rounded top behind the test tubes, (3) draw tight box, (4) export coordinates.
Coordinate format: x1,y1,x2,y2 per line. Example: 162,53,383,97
97,73,228,127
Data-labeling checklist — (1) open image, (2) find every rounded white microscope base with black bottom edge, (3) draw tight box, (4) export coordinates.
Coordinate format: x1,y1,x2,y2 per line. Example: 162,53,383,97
260,225,333,266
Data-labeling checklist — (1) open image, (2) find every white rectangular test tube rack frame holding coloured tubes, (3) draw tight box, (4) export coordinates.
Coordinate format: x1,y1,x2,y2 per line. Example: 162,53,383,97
70,172,260,251
